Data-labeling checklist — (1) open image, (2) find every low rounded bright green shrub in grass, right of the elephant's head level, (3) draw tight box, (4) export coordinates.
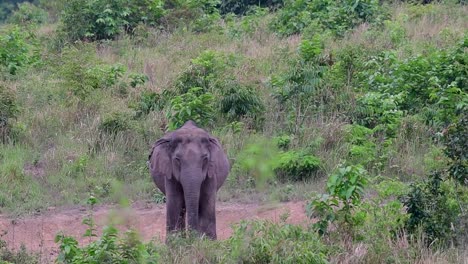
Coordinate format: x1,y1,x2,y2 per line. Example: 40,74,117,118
275,151,321,181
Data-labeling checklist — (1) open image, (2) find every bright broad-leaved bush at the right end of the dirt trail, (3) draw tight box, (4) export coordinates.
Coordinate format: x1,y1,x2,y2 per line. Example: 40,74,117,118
307,166,368,234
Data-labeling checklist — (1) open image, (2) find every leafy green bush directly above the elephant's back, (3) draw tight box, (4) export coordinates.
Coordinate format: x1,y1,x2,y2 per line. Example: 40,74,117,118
167,87,214,130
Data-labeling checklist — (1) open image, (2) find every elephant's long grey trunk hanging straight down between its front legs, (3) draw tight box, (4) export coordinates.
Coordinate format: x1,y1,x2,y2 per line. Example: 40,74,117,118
181,169,203,235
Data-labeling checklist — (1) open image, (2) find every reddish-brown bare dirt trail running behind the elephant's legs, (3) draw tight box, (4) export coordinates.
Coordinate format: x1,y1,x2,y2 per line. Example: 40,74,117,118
0,202,307,263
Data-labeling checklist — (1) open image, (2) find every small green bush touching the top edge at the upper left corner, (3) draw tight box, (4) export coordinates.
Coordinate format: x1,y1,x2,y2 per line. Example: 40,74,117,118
9,2,47,25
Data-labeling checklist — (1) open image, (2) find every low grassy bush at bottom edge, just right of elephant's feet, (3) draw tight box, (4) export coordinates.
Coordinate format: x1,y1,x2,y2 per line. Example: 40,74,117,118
228,221,327,264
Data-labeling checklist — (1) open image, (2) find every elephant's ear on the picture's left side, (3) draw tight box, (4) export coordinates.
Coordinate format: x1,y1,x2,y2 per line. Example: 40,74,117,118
148,134,172,187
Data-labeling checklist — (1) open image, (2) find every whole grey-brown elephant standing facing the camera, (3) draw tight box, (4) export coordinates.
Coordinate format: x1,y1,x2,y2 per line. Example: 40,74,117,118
148,120,231,240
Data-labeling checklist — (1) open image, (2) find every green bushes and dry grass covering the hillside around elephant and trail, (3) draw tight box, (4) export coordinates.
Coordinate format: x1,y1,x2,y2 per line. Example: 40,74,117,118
0,0,468,263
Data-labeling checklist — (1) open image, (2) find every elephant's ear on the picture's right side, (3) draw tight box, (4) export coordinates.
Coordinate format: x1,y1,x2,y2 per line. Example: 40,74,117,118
208,137,231,189
